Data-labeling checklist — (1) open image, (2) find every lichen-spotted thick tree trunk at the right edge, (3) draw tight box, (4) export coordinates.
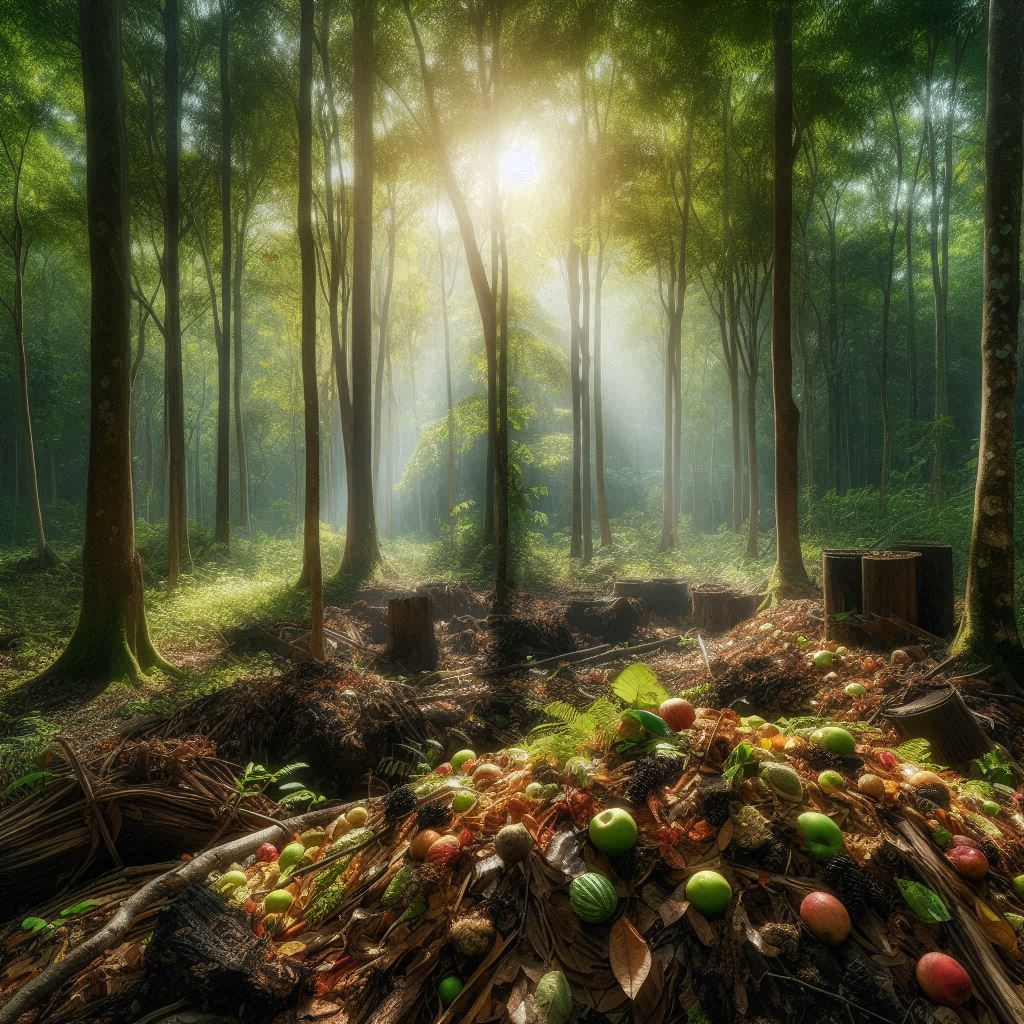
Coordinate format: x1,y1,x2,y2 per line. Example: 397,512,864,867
952,0,1024,693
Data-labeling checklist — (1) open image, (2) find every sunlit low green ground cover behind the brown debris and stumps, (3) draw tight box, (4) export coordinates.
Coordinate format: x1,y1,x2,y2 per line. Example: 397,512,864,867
0,524,790,774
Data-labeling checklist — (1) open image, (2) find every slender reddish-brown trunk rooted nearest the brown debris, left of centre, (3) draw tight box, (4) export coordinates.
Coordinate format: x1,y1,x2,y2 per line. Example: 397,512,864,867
299,0,324,662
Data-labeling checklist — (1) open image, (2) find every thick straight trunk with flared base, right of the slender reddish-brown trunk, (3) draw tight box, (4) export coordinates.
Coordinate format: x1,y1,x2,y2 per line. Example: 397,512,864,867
341,0,380,579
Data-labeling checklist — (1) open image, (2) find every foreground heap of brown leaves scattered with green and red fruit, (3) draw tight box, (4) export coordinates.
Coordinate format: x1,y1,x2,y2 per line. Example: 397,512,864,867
2,621,1024,1024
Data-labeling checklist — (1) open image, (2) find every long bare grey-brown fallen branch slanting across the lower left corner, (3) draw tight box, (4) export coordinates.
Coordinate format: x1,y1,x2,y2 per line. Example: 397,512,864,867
0,801,355,1024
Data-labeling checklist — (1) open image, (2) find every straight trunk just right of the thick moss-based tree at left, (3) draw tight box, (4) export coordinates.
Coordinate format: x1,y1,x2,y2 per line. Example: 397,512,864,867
164,0,188,590
